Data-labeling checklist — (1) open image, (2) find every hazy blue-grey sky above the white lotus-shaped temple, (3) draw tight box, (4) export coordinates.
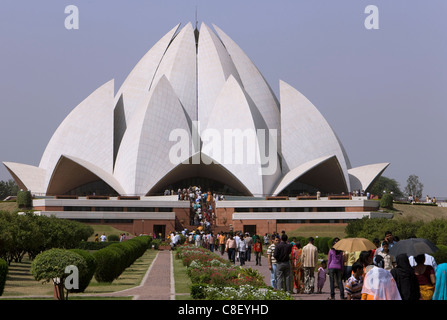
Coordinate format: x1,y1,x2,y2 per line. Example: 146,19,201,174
0,0,447,197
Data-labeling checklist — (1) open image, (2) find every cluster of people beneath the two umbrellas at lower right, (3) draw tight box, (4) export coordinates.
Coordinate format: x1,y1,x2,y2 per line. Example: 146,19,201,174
327,231,445,300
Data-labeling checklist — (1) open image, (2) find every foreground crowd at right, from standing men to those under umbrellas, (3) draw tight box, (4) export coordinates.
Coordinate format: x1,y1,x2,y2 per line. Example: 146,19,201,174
260,231,447,300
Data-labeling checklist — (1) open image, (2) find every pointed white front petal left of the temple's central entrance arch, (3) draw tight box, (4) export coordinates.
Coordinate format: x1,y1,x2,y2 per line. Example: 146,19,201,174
114,76,191,195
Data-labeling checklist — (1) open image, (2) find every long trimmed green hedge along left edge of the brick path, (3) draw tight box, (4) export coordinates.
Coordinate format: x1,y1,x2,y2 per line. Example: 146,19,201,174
93,236,152,282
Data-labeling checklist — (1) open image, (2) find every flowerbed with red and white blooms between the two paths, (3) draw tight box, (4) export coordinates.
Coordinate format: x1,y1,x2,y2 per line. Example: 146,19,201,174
176,245,292,300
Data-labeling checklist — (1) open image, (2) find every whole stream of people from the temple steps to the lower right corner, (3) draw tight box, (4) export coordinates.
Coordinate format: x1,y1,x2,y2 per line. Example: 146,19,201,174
166,229,447,300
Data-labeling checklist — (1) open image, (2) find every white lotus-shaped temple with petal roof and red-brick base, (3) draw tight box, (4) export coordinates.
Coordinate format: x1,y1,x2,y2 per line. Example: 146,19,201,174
3,23,389,234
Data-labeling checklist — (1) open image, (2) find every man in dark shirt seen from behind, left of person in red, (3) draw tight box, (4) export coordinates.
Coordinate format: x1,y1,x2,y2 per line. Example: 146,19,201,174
273,233,293,293
